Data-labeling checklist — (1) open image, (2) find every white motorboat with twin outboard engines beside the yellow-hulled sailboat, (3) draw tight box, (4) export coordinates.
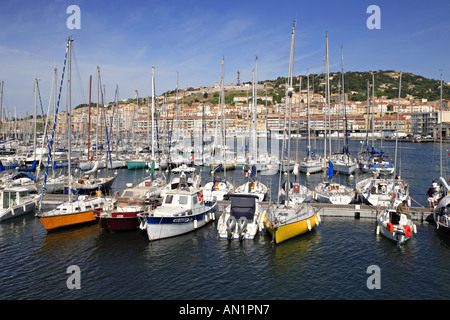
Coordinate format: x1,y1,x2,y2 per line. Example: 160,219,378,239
217,194,264,240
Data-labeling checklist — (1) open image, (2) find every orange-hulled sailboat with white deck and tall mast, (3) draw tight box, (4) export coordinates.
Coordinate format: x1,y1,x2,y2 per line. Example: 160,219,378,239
36,37,113,231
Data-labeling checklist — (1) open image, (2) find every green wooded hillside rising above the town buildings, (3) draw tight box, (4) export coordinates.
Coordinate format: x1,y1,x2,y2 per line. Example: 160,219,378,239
77,70,450,108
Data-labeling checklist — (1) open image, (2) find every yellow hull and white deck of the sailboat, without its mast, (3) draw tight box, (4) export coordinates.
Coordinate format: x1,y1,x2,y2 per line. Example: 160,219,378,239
264,203,320,243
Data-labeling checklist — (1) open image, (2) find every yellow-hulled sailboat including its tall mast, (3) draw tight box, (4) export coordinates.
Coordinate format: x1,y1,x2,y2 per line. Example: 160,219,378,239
263,22,320,244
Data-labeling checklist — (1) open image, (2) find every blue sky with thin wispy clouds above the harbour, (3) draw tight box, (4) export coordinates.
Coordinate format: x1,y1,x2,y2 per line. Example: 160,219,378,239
0,0,450,117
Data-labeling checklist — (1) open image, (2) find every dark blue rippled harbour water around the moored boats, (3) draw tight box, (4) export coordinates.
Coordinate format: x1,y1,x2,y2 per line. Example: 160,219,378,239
0,140,450,300
